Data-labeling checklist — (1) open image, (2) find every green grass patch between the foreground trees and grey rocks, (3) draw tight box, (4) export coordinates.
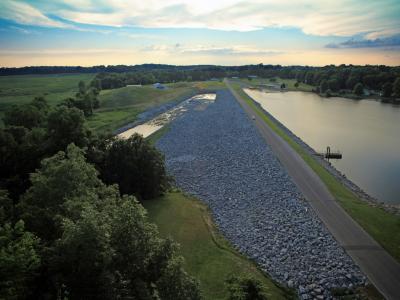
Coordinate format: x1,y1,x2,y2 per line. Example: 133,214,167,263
144,192,295,300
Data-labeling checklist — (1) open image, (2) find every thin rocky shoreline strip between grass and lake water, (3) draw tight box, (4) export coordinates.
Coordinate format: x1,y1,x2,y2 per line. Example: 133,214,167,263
245,92,400,215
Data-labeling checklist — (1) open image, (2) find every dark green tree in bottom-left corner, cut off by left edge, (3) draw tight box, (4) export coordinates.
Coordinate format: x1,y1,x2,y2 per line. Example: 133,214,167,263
0,221,40,299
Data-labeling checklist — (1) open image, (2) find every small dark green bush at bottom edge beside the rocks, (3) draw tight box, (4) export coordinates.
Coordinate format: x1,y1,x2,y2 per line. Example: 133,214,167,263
226,275,268,300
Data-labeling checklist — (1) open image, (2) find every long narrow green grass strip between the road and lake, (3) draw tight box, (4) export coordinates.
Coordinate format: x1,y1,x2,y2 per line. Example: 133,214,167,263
228,83,400,261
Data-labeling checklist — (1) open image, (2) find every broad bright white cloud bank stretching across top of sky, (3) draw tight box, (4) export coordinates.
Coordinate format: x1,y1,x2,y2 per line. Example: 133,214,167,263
0,0,400,39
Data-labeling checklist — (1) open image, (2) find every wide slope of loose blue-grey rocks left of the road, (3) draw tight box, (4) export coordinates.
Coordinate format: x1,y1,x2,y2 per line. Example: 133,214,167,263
157,91,366,299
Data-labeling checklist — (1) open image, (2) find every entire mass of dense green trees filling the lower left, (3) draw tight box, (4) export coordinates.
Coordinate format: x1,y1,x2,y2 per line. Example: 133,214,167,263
0,86,205,299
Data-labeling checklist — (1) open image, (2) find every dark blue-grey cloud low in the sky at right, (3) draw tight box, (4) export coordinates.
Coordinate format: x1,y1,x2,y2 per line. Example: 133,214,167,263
325,35,400,49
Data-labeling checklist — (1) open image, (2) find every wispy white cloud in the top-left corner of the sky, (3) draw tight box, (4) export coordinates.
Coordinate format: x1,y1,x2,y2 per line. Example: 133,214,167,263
0,0,66,27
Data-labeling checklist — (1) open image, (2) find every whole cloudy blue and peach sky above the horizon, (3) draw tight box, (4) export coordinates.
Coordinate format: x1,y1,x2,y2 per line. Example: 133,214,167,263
0,0,400,67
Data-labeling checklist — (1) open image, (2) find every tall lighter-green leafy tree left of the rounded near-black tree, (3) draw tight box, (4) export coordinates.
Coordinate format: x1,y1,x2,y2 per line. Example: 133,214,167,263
19,145,102,242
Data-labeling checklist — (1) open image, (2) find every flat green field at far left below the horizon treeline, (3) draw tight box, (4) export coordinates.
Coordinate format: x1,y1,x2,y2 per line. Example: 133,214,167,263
0,74,94,124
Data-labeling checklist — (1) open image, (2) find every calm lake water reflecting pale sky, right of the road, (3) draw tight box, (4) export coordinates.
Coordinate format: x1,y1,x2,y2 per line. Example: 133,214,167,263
246,90,400,204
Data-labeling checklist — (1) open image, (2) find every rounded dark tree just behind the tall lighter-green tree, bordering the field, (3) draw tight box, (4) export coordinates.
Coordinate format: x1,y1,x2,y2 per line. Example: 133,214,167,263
47,106,90,153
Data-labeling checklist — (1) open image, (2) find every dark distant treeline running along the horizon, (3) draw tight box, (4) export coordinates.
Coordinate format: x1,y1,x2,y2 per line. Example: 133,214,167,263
0,64,400,98
